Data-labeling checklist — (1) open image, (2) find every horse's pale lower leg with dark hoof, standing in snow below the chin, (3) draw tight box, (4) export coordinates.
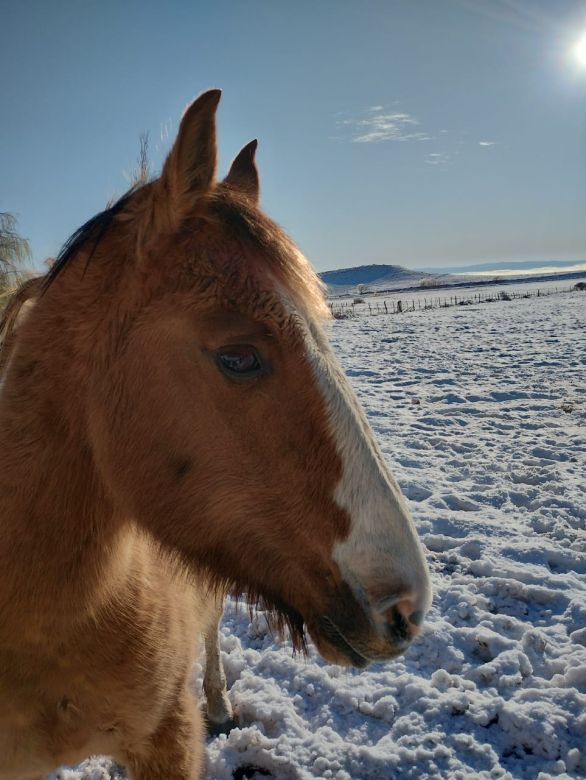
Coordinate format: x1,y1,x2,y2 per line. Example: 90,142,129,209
203,601,236,734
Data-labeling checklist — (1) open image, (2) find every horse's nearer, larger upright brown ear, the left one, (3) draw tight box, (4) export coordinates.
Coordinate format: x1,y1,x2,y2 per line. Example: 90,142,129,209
160,89,222,218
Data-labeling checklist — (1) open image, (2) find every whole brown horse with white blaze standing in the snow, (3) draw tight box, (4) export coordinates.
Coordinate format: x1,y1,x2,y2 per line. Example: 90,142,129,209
0,90,431,780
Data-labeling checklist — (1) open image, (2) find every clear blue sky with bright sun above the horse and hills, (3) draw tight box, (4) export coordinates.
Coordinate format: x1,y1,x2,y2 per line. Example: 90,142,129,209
0,0,586,271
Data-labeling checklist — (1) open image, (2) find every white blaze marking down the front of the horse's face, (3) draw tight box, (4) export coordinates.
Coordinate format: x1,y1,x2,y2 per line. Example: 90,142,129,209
307,320,430,611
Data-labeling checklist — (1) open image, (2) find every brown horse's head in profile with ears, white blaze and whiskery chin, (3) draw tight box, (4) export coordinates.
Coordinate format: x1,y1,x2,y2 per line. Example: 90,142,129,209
39,90,430,667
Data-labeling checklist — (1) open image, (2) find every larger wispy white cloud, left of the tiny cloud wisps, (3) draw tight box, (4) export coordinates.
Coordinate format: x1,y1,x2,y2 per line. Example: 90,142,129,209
336,105,431,144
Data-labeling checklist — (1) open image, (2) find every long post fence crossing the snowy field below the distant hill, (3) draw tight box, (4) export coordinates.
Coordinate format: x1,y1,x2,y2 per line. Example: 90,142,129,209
329,287,574,319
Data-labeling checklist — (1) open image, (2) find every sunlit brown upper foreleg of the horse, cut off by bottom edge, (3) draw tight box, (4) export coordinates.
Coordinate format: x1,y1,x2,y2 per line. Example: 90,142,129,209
123,690,203,780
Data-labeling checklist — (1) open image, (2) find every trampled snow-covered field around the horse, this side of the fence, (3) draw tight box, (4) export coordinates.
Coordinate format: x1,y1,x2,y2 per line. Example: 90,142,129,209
52,293,586,780
